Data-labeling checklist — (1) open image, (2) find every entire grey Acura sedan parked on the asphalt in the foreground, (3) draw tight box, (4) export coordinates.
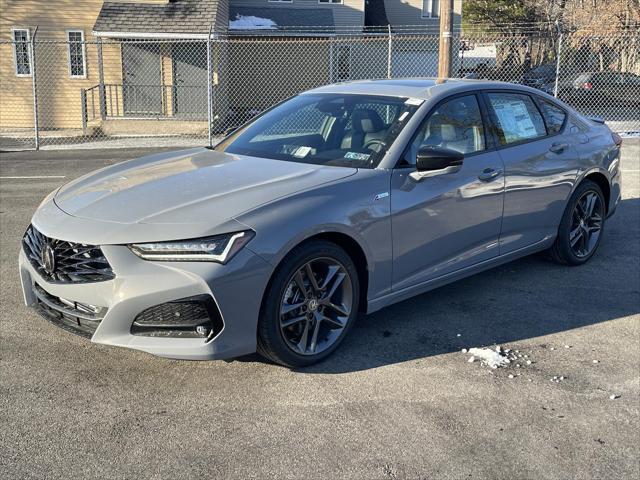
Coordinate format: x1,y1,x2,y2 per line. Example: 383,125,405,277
20,79,621,367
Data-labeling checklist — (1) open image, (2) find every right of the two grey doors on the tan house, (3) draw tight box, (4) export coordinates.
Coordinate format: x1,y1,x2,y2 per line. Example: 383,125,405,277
173,42,208,120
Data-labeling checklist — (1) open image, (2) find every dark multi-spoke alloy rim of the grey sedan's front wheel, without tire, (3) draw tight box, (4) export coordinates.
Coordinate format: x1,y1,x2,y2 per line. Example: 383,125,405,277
280,258,354,355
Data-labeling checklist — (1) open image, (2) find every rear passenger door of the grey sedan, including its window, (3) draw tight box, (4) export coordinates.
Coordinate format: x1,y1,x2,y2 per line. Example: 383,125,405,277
485,91,579,254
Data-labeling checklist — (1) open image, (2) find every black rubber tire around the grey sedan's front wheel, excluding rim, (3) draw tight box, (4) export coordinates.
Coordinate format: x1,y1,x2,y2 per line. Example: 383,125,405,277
258,240,360,368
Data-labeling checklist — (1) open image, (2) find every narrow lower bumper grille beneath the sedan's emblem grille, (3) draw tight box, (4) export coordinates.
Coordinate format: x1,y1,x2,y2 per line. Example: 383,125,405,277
33,283,107,338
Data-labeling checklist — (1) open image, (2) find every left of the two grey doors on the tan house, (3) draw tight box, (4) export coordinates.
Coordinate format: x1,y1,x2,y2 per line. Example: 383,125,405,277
122,42,164,116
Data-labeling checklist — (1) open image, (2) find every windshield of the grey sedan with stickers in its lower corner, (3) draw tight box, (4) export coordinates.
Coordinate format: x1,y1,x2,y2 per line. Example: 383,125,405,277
215,94,421,168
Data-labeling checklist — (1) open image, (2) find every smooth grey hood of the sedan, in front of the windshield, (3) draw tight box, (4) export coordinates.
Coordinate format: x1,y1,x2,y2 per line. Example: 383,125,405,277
54,148,357,227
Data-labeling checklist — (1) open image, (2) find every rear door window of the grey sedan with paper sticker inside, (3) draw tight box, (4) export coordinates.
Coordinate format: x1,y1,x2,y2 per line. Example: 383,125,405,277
487,93,547,145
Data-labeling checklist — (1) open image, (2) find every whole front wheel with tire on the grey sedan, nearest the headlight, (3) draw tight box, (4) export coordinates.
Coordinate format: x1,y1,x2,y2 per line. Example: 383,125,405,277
258,241,360,367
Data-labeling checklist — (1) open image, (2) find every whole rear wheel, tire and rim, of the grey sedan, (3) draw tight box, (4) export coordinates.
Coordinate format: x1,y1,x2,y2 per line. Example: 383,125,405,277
551,180,606,265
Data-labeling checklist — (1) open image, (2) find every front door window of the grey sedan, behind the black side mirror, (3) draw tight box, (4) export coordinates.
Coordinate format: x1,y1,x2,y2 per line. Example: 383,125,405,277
404,95,485,165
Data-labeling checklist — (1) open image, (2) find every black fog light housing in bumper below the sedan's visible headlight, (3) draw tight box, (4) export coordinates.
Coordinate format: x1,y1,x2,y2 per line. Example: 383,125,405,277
131,295,223,340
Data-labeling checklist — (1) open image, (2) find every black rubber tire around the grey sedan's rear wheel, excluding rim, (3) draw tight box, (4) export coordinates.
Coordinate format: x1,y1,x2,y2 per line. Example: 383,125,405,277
549,180,607,266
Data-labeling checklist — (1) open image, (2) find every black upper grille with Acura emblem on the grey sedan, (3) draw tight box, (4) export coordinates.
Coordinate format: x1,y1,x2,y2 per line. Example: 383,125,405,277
22,225,115,283
